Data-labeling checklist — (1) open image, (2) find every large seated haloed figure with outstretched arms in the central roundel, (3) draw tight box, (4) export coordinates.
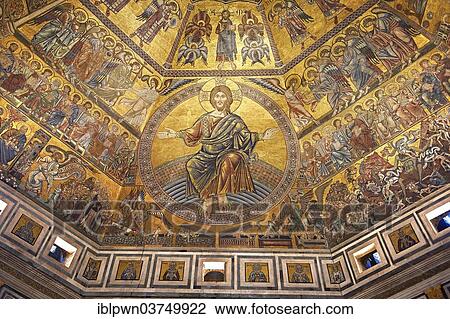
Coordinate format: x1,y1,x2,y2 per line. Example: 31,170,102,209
158,85,278,212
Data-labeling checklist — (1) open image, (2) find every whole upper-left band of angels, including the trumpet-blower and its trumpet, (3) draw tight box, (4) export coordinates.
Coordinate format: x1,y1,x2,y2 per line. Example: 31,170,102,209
23,3,200,134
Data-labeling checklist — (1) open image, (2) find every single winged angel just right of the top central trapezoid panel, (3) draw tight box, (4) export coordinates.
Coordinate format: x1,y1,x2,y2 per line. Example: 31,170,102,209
268,0,316,49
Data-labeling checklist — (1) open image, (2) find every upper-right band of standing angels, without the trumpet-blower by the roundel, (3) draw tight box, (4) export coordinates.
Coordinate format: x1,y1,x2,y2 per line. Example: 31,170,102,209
303,8,419,115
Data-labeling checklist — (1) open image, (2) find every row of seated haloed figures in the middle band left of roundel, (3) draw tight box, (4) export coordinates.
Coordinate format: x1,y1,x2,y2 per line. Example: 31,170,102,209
0,42,136,179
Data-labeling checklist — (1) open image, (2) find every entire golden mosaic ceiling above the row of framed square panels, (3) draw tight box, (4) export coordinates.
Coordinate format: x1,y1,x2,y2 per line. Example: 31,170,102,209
0,0,450,249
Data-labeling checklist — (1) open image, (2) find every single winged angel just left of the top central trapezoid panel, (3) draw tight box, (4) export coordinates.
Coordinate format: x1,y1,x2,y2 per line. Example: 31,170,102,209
130,0,182,47
